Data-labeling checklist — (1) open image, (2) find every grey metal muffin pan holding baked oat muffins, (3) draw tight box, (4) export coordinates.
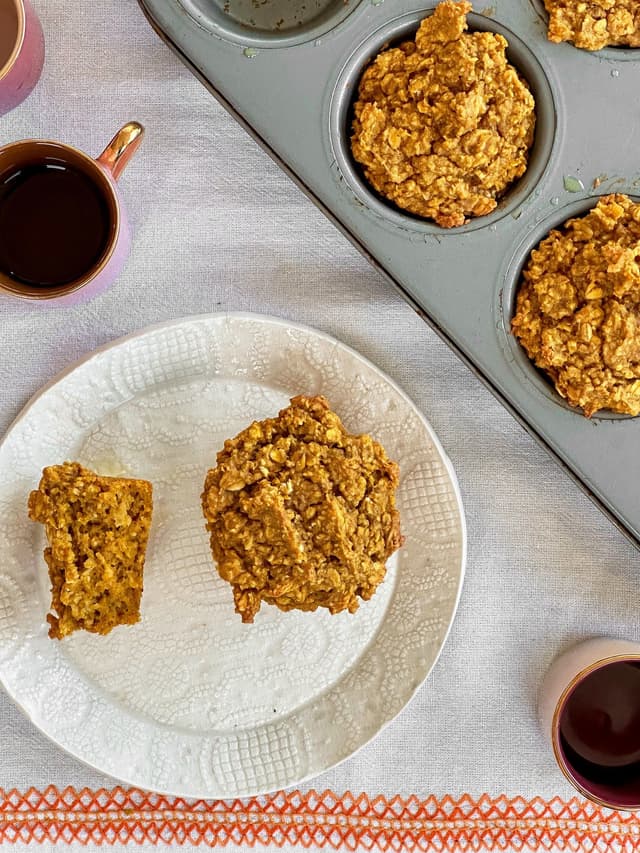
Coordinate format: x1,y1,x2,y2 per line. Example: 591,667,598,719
139,0,640,547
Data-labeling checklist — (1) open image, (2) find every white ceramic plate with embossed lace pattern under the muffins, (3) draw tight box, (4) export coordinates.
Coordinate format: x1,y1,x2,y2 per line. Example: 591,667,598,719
0,314,465,798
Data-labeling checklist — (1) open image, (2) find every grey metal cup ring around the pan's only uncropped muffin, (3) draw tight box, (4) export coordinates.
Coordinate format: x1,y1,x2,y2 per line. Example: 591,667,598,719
330,3,557,235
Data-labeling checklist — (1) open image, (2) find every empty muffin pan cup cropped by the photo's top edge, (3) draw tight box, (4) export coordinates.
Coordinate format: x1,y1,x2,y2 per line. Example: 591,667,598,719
178,0,362,47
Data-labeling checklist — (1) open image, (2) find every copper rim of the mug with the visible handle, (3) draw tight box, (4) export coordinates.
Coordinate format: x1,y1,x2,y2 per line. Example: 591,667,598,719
0,137,122,302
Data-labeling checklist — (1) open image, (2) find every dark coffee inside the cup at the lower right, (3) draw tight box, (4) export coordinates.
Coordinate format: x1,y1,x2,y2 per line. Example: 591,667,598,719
560,661,640,794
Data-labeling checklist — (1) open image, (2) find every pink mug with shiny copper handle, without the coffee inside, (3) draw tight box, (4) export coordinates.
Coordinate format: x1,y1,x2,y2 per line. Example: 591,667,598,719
0,121,144,306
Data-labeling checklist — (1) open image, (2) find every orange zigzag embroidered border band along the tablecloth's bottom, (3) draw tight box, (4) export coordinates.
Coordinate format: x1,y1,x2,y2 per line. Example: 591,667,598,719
0,787,640,853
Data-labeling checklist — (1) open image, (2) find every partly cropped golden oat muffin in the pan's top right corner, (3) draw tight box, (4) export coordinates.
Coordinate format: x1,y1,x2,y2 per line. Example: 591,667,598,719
545,0,640,50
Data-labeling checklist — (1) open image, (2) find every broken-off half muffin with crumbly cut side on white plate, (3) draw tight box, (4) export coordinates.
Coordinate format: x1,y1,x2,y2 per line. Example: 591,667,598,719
29,462,152,640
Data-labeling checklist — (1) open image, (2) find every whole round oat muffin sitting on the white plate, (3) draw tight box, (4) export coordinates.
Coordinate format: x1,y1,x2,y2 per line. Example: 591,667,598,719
202,396,402,622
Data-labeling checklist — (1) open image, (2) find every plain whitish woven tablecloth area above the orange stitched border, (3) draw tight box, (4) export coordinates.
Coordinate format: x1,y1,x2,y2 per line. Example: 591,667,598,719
0,0,640,844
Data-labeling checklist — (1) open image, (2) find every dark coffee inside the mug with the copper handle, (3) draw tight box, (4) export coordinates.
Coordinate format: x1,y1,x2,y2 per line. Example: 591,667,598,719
0,161,111,287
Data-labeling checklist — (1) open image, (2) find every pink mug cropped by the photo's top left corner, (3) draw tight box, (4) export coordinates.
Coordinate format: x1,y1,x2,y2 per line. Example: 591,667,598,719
0,0,44,116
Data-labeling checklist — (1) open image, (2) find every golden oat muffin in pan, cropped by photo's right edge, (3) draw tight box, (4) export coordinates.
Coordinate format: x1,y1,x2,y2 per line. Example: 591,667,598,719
512,195,640,417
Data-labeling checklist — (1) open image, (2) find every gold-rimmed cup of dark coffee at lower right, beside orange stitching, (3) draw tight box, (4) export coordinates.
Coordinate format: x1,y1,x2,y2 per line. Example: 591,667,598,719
538,637,640,811
